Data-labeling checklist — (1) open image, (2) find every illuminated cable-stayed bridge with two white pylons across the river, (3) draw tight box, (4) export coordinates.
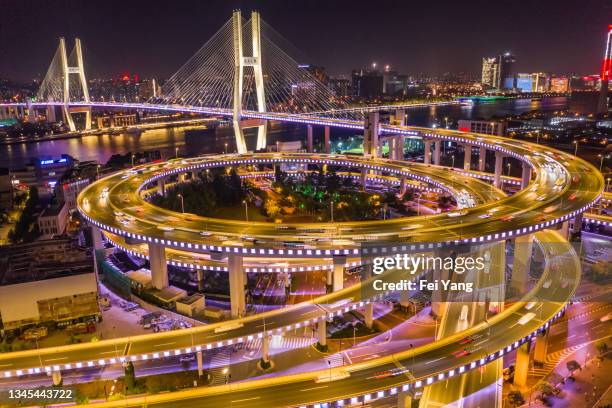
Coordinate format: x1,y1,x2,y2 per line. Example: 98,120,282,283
0,10,455,153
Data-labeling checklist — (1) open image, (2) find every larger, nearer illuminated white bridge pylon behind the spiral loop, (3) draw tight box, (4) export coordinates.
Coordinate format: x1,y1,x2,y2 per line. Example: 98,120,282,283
232,10,266,153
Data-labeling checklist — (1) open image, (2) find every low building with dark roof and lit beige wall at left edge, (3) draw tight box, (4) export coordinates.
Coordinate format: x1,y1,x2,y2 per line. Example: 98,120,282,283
0,238,101,333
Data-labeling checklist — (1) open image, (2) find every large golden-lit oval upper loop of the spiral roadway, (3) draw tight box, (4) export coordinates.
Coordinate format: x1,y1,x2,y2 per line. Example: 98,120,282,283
77,128,604,257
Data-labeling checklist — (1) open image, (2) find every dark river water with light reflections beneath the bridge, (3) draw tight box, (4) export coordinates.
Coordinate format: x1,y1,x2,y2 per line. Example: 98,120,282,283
0,97,568,168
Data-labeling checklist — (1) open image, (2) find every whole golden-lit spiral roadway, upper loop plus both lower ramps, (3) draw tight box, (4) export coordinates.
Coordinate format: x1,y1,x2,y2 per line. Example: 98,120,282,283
0,127,603,406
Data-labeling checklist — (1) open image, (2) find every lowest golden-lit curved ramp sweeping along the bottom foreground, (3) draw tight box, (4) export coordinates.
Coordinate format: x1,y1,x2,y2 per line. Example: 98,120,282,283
69,231,580,407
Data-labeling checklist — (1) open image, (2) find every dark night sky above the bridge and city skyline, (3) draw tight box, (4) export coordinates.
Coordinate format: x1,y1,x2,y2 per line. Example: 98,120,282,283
0,0,612,80
